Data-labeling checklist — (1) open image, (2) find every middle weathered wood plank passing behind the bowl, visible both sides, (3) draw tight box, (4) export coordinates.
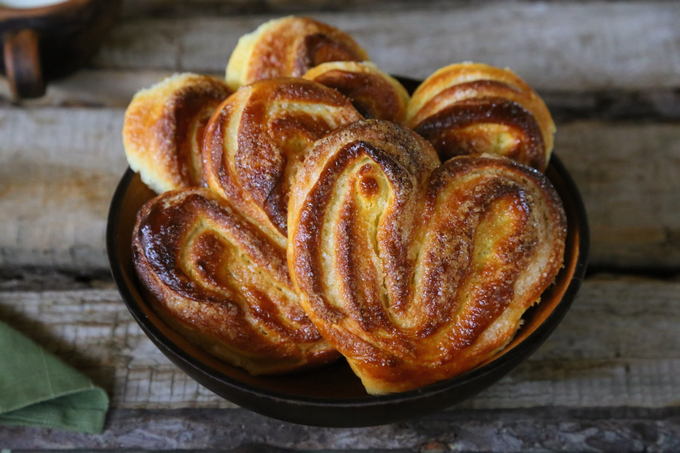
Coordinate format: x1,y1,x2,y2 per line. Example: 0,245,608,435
0,108,680,272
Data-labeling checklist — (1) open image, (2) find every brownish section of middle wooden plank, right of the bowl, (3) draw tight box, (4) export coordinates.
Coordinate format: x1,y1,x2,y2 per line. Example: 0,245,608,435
555,122,680,269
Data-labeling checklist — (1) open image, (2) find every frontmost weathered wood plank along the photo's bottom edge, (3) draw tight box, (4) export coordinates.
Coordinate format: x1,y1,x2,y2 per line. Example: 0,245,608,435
0,408,680,453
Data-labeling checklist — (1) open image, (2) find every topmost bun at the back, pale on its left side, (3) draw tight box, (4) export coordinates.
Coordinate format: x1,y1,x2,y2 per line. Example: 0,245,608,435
226,16,368,90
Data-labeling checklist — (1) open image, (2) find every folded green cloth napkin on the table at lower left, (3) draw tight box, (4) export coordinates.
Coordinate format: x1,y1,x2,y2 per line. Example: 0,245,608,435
0,322,109,433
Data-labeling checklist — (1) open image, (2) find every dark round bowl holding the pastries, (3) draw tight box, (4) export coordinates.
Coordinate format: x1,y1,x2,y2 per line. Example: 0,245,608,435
107,78,588,426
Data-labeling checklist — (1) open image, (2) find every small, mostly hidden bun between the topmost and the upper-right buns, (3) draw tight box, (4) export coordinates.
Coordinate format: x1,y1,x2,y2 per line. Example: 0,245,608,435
304,61,408,123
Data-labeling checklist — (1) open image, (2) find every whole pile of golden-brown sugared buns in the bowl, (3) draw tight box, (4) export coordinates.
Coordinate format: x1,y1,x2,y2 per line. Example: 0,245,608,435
123,17,566,394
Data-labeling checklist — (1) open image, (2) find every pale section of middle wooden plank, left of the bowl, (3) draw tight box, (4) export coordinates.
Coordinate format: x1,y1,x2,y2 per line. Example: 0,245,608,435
0,109,126,269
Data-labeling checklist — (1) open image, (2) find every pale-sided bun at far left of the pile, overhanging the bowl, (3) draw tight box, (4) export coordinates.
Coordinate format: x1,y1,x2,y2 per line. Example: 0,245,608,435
123,74,230,193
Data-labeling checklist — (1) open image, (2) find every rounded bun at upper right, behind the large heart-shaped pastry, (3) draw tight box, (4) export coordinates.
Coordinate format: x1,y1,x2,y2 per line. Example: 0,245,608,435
406,63,555,171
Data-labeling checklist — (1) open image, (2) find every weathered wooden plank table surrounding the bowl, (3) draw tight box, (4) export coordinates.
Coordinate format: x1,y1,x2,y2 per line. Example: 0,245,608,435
0,0,680,451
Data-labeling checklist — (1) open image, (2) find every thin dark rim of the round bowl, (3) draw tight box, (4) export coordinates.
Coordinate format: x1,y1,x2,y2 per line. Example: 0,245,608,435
106,77,590,408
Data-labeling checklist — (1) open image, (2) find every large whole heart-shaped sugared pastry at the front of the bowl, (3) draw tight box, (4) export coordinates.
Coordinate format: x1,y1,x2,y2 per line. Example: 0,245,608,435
288,120,566,394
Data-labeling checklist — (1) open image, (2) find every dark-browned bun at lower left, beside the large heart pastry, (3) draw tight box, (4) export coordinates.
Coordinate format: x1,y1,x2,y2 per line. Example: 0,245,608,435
132,189,337,374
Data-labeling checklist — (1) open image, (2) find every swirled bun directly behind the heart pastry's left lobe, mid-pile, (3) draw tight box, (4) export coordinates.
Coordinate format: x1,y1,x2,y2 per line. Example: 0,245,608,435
203,78,362,240
